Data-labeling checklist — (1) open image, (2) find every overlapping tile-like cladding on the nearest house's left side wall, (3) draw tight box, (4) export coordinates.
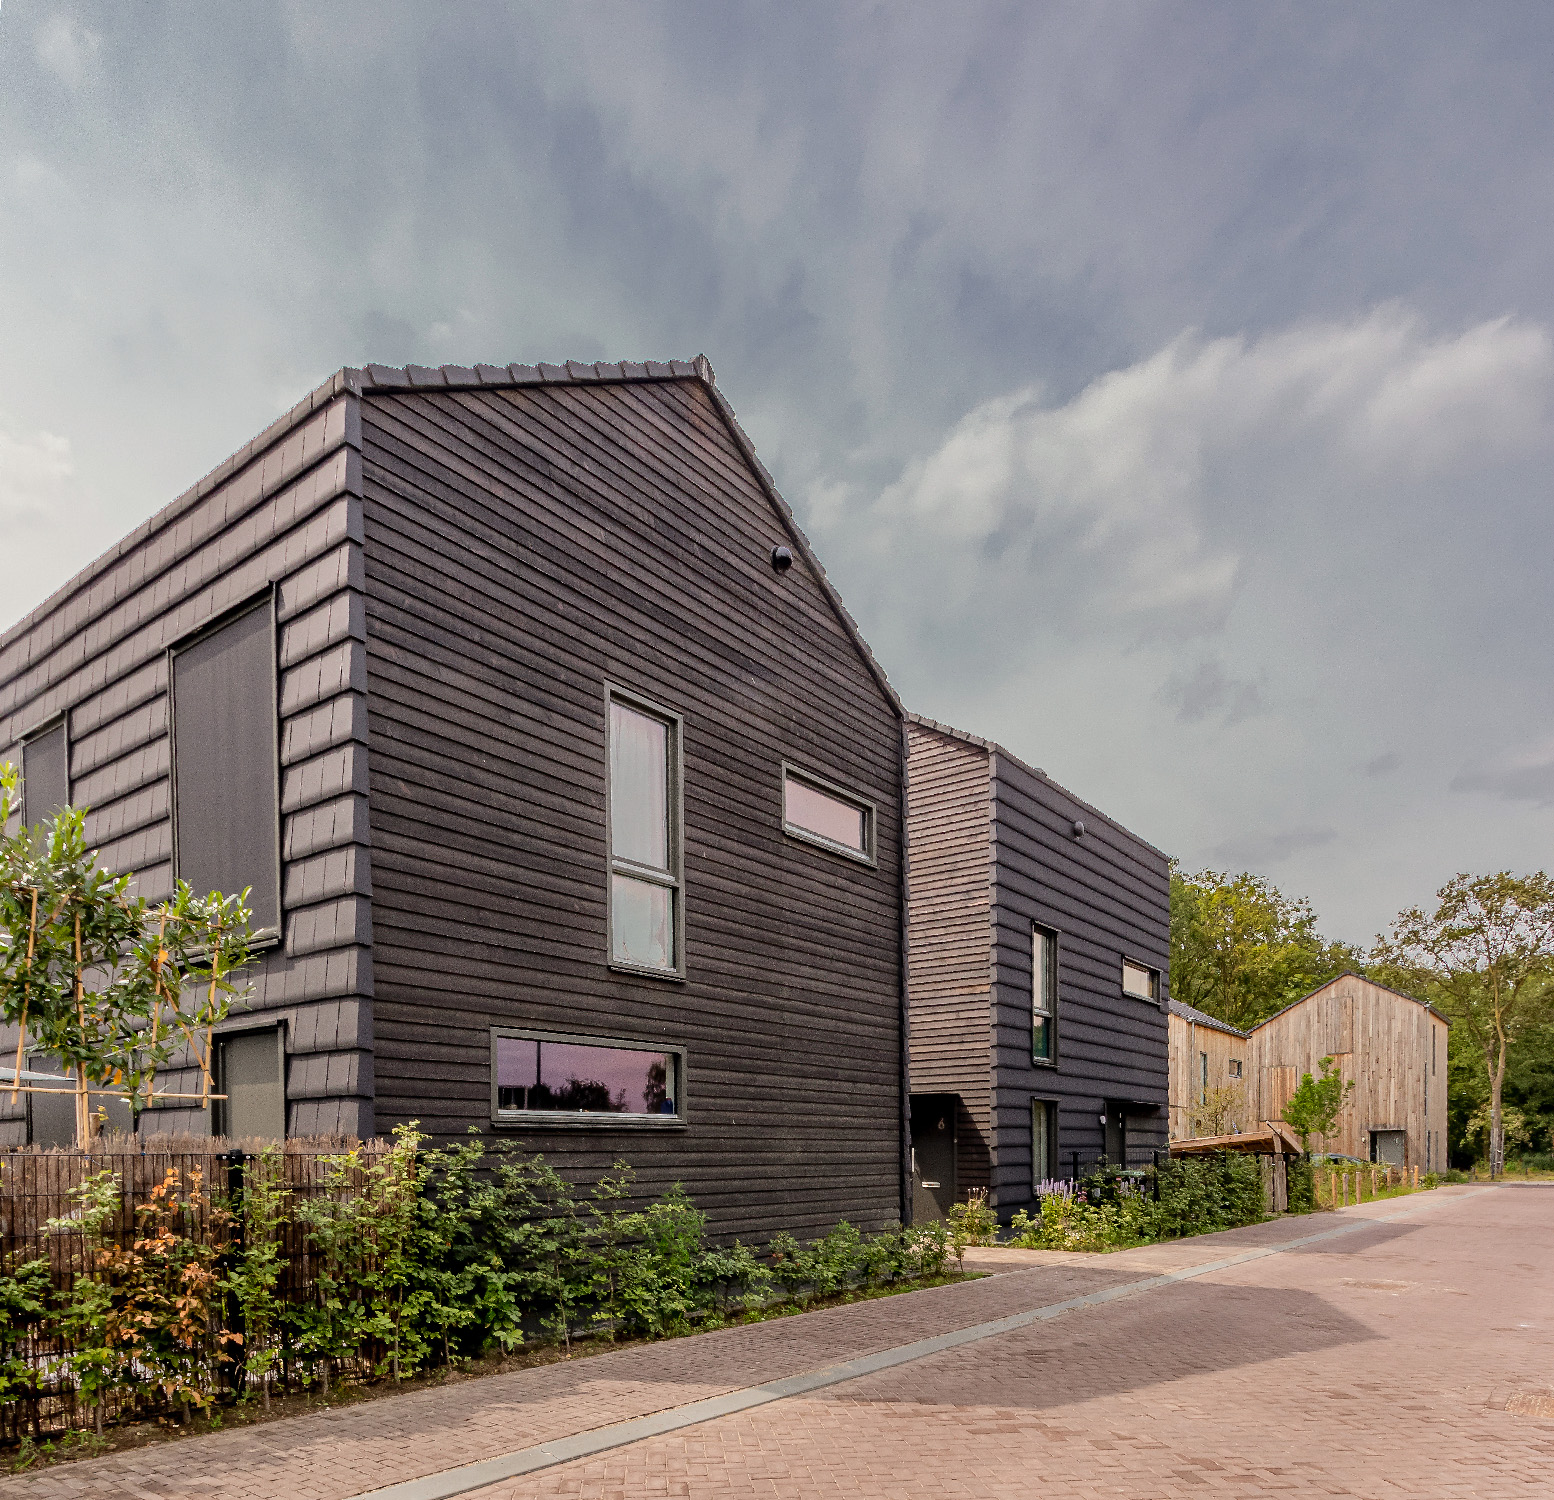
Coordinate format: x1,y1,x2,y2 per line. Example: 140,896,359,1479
0,390,373,1144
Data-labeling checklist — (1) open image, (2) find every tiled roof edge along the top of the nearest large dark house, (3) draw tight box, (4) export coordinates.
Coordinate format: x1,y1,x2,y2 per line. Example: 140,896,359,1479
0,354,906,717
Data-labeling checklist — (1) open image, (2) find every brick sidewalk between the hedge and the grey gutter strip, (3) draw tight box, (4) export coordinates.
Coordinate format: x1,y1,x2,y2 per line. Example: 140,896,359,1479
0,1189,1479,1500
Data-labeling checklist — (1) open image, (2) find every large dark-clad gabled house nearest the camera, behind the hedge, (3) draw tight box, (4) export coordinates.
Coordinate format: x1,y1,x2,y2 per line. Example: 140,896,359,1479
0,359,909,1234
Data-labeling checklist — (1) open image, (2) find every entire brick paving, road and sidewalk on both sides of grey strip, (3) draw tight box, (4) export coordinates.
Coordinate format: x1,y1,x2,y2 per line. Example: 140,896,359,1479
0,1188,1554,1500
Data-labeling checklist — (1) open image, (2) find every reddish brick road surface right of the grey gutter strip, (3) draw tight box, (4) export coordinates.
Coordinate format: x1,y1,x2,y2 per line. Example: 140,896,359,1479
471,1188,1554,1500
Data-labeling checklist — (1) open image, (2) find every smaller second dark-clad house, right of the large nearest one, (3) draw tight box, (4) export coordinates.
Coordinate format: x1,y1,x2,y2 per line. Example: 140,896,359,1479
908,715,1170,1222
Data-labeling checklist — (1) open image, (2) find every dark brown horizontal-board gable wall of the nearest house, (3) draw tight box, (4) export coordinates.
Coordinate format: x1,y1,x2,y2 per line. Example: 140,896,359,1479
362,379,904,1237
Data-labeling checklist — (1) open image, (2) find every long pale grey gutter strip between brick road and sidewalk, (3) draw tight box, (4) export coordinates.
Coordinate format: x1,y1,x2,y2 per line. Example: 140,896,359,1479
351,1188,1492,1500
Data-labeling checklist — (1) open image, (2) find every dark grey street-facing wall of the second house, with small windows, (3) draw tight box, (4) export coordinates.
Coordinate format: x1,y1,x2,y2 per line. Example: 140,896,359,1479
993,754,1170,1219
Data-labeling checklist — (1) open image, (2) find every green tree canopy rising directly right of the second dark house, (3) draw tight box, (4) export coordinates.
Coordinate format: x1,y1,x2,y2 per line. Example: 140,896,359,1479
1170,869,1364,1031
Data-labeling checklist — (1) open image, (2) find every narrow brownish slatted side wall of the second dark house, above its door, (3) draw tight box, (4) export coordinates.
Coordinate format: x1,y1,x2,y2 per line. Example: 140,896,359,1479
908,723,993,1197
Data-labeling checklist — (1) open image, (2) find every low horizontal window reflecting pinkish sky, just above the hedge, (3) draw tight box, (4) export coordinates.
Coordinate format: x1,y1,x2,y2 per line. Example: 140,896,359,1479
496,1037,676,1115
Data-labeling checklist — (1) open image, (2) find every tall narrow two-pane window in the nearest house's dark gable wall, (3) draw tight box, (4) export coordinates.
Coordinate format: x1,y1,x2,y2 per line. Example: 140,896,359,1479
609,693,682,975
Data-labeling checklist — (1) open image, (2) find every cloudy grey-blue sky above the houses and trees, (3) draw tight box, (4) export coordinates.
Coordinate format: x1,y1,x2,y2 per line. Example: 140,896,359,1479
0,0,1554,942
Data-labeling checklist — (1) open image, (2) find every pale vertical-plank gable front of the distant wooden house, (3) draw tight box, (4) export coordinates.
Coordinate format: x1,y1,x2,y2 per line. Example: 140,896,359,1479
1248,975,1448,1170
